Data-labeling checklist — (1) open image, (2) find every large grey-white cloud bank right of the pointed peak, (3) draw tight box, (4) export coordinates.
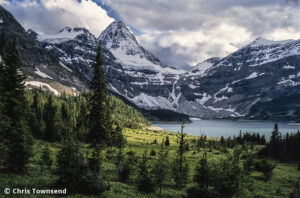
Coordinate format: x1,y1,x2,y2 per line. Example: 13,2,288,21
103,0,300,66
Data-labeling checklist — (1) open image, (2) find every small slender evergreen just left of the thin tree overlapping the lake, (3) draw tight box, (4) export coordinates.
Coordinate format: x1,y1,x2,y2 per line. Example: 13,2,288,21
153,141,169,197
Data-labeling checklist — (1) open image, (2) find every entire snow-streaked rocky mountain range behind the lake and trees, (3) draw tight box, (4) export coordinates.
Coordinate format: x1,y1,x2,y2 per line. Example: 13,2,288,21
0,6,300,120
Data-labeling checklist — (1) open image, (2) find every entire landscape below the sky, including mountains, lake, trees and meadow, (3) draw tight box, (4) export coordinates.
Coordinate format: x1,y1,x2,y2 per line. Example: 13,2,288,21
0,1,300,198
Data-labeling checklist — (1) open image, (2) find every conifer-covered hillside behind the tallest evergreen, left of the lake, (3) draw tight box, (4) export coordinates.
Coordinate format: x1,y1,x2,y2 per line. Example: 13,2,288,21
25,90,149,142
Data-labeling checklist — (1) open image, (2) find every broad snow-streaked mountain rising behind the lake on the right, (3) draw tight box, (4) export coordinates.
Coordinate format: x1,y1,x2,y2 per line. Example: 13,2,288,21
182,38,300,118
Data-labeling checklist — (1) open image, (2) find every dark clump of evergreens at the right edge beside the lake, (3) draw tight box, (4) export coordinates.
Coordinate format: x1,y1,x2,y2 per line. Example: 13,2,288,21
260,124,300,162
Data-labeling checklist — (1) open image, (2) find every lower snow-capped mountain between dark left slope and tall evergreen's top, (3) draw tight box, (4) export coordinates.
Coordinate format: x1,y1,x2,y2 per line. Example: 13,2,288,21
36,26,98,84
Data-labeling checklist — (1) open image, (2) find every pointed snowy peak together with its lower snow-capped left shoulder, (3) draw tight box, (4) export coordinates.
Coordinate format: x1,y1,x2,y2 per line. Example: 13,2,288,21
37,21,192,110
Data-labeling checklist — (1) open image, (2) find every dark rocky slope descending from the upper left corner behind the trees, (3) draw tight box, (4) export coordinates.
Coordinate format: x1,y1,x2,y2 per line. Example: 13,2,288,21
0,6,86,89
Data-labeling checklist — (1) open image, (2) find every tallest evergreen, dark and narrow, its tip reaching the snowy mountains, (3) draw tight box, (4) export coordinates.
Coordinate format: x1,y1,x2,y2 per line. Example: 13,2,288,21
88,45,112,146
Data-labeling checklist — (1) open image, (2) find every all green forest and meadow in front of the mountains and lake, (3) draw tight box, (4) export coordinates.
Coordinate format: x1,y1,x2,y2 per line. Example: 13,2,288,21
0,42,300,198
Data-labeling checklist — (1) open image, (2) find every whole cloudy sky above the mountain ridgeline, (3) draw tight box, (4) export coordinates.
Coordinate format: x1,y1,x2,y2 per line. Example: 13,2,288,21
0,0,300,68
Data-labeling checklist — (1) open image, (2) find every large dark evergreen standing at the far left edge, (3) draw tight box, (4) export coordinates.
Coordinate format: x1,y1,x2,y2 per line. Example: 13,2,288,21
1,40,33,172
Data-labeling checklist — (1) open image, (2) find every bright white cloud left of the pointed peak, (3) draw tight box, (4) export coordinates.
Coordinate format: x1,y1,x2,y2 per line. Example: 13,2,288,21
0,0,114,36
